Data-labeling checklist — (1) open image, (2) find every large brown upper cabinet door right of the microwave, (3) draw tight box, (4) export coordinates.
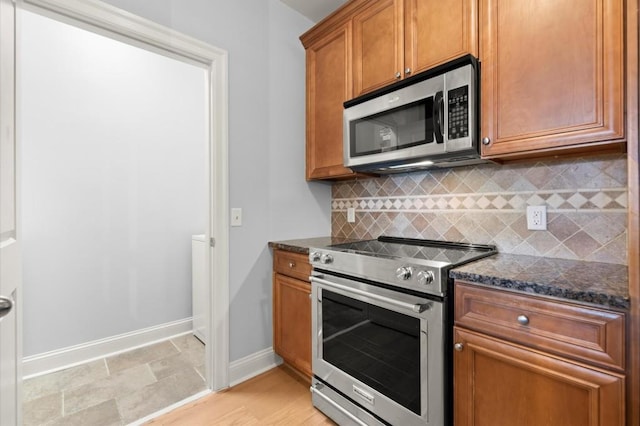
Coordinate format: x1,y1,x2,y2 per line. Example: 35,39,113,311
480,0,624,158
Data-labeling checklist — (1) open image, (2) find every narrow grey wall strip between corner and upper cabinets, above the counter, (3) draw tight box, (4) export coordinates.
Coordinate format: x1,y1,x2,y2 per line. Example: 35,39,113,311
269,1,331,239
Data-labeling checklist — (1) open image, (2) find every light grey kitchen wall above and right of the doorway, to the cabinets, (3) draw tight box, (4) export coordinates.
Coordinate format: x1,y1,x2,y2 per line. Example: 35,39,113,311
21,0,331,361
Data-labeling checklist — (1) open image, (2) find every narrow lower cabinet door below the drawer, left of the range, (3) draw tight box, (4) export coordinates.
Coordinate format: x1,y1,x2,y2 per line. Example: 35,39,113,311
273,274,311,377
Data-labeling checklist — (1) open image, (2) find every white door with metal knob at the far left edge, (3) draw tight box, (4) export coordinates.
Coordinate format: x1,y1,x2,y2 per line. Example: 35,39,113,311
0,0,22,426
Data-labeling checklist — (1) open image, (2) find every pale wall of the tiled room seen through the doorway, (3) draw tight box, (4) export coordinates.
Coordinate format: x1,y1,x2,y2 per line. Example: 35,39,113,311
19,12,207,356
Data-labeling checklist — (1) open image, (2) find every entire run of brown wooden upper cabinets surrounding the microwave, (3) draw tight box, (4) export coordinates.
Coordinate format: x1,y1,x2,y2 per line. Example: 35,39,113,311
301,0,625,179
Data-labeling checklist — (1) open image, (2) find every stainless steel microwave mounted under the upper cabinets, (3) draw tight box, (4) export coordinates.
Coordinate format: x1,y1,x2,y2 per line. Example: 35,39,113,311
343,55,484,173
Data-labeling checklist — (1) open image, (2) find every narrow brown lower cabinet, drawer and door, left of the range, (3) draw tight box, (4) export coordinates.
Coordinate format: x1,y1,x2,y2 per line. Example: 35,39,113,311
273,250,311,380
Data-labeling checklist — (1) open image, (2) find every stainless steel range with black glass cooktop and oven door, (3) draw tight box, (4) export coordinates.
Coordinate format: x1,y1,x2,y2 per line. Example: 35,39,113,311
309,237,496,426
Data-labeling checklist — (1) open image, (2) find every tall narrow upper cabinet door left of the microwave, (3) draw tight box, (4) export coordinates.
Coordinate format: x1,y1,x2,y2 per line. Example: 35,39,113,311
306,24,354,180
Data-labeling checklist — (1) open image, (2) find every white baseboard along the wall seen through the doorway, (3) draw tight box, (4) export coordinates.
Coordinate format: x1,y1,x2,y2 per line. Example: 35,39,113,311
22,318,193,379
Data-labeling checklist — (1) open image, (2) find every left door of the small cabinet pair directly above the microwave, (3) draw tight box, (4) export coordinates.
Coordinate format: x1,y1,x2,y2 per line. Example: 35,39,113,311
353,0,404,97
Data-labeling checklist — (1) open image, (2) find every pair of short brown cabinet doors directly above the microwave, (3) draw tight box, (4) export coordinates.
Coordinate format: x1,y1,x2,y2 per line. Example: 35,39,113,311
353,0,478,97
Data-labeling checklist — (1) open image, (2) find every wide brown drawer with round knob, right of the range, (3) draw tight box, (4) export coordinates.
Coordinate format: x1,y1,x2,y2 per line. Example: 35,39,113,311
454,282,625,371
